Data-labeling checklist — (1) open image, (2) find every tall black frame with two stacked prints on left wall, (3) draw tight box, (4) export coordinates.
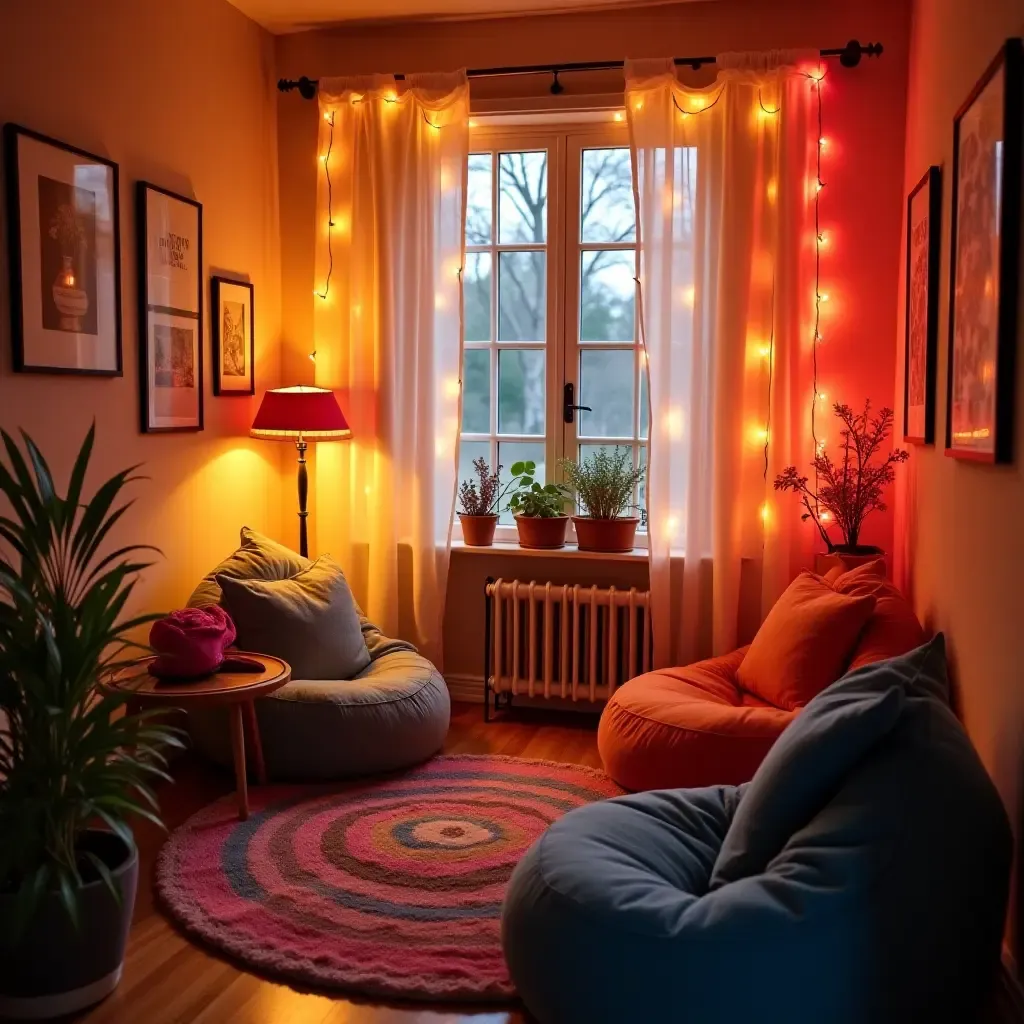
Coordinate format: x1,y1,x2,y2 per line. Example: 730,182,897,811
135,181,204,433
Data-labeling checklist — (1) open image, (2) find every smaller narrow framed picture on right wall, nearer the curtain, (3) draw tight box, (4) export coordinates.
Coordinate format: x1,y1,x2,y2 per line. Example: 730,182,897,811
903,167,942,444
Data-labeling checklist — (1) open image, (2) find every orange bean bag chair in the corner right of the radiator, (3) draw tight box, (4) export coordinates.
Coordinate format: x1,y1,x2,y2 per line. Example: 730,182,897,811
597,561,926,791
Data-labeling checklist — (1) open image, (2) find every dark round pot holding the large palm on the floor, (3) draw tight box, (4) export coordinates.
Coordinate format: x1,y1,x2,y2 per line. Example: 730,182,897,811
0,829,138,1020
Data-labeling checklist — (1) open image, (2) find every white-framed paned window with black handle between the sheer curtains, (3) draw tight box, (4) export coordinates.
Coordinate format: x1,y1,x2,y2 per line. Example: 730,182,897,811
459,124,647,537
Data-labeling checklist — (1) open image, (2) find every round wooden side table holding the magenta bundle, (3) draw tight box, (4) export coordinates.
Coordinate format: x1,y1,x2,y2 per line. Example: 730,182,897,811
104,650,292,821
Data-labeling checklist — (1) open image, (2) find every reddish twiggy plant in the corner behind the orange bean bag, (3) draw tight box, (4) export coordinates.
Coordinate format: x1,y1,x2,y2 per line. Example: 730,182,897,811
775,400,909,551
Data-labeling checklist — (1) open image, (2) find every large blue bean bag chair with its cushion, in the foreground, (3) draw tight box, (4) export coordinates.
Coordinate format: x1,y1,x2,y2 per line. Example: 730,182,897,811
502,636,1012,1024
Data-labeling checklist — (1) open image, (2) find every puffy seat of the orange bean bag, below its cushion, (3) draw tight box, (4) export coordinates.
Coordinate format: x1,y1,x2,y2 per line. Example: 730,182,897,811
597,647,794,790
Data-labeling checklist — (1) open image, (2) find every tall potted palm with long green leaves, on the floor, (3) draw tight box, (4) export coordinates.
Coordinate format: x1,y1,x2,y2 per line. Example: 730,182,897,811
0,428,181,1018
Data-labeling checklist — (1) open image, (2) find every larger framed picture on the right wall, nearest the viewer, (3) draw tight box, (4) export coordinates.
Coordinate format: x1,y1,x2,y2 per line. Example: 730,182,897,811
946,39,1024,463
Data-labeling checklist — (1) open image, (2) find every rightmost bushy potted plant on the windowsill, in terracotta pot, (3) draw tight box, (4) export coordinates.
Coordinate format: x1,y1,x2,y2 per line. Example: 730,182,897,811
561,447,644,552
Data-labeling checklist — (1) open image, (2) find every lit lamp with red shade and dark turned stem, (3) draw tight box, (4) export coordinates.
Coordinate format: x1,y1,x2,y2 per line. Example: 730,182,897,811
249,385,352,558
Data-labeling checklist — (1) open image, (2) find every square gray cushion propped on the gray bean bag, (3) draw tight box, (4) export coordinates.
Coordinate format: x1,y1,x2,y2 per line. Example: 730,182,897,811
217,555,370,679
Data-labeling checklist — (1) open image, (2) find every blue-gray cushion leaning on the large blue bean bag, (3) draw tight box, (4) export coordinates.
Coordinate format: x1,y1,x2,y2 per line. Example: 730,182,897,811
712,647,905,888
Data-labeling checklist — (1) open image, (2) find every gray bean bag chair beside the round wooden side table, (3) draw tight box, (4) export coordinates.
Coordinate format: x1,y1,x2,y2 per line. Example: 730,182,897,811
188,527,451,781
